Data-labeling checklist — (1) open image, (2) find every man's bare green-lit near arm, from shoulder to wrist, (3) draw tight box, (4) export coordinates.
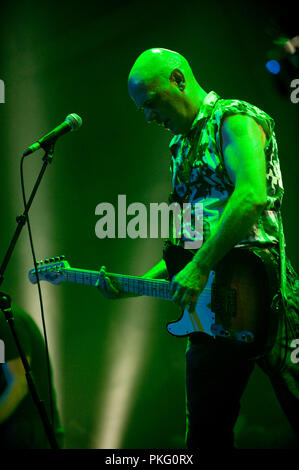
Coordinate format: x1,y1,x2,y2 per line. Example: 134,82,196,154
194,115,267,272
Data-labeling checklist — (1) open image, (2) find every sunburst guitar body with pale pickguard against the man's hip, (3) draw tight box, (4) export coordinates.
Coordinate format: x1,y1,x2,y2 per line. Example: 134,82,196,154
164,245,278,345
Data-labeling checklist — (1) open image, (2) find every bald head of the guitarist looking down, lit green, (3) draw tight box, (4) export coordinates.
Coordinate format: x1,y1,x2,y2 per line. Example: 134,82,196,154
128,48,206,134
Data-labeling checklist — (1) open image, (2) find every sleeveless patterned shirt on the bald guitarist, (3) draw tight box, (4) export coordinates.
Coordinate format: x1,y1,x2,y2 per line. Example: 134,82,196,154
169,91,284,246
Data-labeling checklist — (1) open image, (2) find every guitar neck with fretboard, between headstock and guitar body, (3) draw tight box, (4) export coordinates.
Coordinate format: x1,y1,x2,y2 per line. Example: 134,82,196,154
61,268,171,300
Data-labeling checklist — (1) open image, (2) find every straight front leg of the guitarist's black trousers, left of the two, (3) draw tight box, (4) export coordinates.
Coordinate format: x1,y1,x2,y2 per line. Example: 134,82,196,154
186,334,254,450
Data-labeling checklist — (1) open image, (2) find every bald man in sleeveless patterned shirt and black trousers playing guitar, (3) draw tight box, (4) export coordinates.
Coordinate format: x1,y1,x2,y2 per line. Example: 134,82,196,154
98,48,299,450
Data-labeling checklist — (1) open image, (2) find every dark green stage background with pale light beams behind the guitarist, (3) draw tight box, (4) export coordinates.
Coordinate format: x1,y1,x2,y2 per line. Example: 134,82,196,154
0,0,299,448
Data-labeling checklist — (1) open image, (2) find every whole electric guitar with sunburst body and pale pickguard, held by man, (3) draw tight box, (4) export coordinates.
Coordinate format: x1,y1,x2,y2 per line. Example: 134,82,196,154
28,246,275,344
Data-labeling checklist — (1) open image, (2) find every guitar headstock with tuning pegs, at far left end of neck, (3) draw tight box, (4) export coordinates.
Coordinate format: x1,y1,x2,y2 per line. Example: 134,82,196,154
28,256,70,284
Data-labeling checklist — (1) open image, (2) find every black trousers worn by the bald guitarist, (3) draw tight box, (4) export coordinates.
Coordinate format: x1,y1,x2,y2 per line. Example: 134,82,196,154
186,333,299,452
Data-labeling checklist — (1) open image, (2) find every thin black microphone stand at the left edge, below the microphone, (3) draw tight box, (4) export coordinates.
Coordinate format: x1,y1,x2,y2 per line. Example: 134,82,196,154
0,142,59,449
